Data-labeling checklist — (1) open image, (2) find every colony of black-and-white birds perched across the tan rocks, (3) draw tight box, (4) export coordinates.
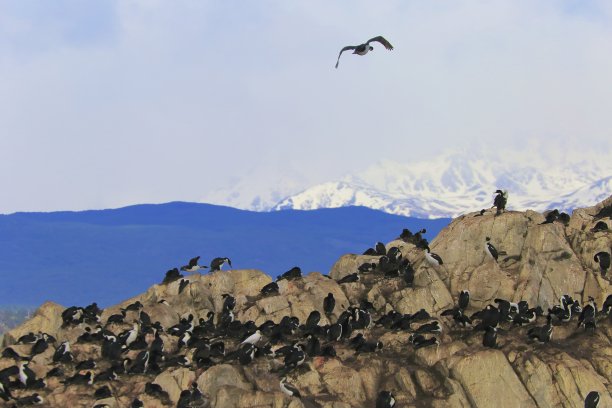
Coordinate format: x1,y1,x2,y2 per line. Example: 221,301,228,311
0,190,612,408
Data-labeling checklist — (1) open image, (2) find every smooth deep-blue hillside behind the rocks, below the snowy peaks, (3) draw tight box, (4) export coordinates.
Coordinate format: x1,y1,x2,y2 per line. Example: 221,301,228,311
0,202,450,306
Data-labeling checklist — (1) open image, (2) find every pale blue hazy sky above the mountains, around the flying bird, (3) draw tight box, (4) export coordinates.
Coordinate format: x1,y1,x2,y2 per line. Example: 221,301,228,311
0,0,612,213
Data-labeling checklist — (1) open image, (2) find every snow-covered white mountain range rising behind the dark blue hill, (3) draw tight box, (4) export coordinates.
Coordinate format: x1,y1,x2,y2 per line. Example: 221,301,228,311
202,153,612,218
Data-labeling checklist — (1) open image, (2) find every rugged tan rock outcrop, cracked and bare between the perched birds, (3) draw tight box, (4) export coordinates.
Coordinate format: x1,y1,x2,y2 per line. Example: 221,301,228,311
0,197,612,408
